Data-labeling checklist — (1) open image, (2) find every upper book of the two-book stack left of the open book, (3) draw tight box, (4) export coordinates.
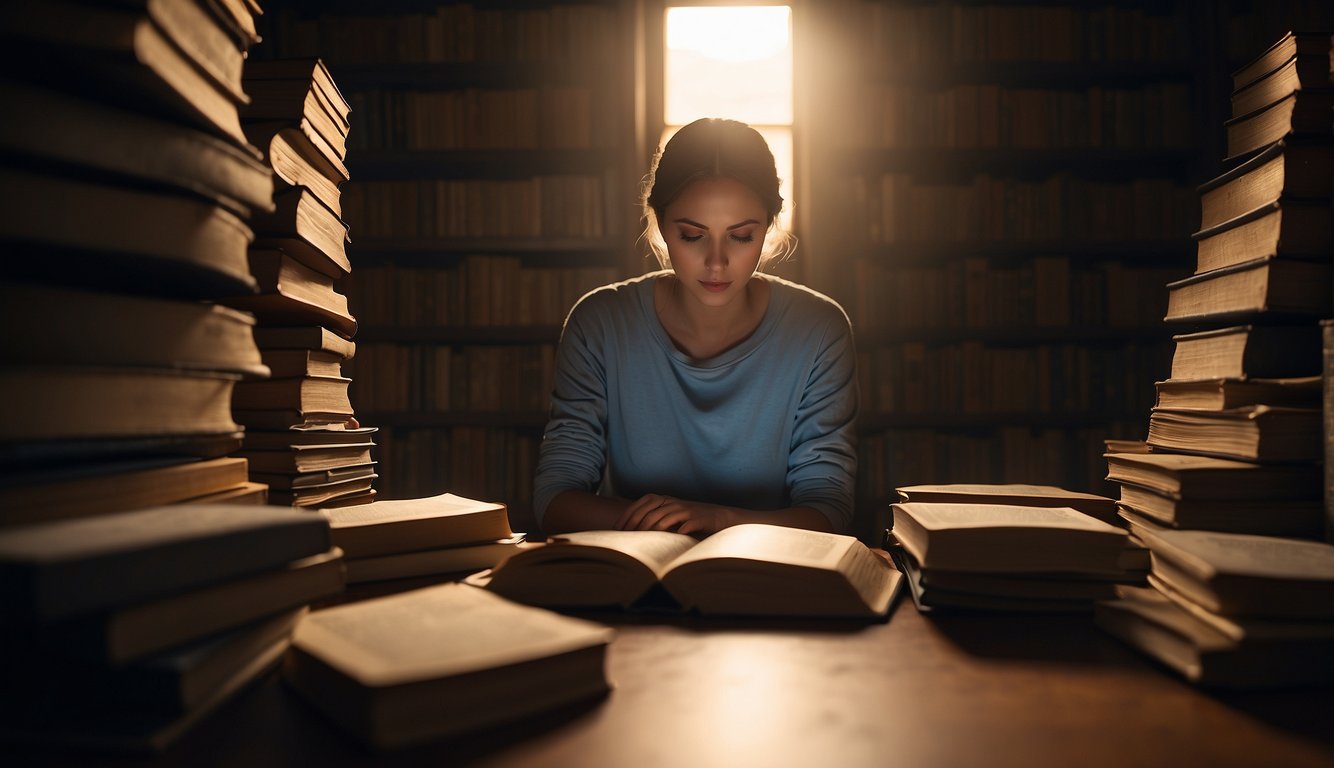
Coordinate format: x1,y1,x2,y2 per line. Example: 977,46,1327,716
327,493,514,559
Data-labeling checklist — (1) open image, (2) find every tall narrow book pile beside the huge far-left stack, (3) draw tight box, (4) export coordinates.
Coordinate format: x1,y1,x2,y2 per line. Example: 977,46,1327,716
225,59,376,507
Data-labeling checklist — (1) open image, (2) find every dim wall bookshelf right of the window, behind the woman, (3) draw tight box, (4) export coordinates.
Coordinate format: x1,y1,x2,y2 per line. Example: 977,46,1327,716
806,0,1213,536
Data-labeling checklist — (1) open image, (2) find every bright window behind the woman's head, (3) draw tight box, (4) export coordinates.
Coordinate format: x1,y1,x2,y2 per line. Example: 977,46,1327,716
662,5,794,228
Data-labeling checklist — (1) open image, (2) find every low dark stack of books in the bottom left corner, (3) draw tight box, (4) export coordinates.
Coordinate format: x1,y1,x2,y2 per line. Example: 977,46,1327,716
0,504,343,752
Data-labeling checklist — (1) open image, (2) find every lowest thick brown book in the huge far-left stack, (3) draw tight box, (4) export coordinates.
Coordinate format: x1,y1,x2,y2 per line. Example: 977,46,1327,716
0,456,247,525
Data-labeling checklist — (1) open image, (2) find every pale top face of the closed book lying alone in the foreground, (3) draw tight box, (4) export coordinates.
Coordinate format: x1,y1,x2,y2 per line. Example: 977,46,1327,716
292,584,612,685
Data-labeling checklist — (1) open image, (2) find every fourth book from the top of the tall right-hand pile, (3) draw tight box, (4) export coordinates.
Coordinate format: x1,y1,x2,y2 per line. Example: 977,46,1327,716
1191,197,1334,272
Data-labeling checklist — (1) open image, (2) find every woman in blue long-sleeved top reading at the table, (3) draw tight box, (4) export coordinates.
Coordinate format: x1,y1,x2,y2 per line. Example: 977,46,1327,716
534,119,856,536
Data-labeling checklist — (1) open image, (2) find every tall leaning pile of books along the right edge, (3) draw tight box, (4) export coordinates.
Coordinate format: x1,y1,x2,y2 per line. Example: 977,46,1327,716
1098,33,1334,687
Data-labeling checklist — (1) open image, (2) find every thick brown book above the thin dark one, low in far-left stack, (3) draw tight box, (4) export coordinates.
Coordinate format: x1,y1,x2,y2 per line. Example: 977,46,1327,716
0,365,239,443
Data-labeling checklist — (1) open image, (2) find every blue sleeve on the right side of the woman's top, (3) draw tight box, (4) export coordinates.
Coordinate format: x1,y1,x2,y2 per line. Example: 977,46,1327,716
787,312,858,532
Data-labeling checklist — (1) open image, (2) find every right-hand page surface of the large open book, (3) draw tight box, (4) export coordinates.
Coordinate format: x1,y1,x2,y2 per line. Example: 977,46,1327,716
668,524,852,571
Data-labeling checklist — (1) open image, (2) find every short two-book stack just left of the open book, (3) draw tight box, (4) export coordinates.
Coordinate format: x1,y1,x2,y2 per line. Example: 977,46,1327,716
324,493,524,583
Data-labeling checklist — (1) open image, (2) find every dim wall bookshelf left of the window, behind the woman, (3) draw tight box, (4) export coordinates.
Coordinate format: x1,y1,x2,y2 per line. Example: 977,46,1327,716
264,0,642,529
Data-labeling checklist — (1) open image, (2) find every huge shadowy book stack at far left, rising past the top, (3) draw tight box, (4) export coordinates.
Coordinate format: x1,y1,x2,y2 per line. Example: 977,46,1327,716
0,0,273,524
